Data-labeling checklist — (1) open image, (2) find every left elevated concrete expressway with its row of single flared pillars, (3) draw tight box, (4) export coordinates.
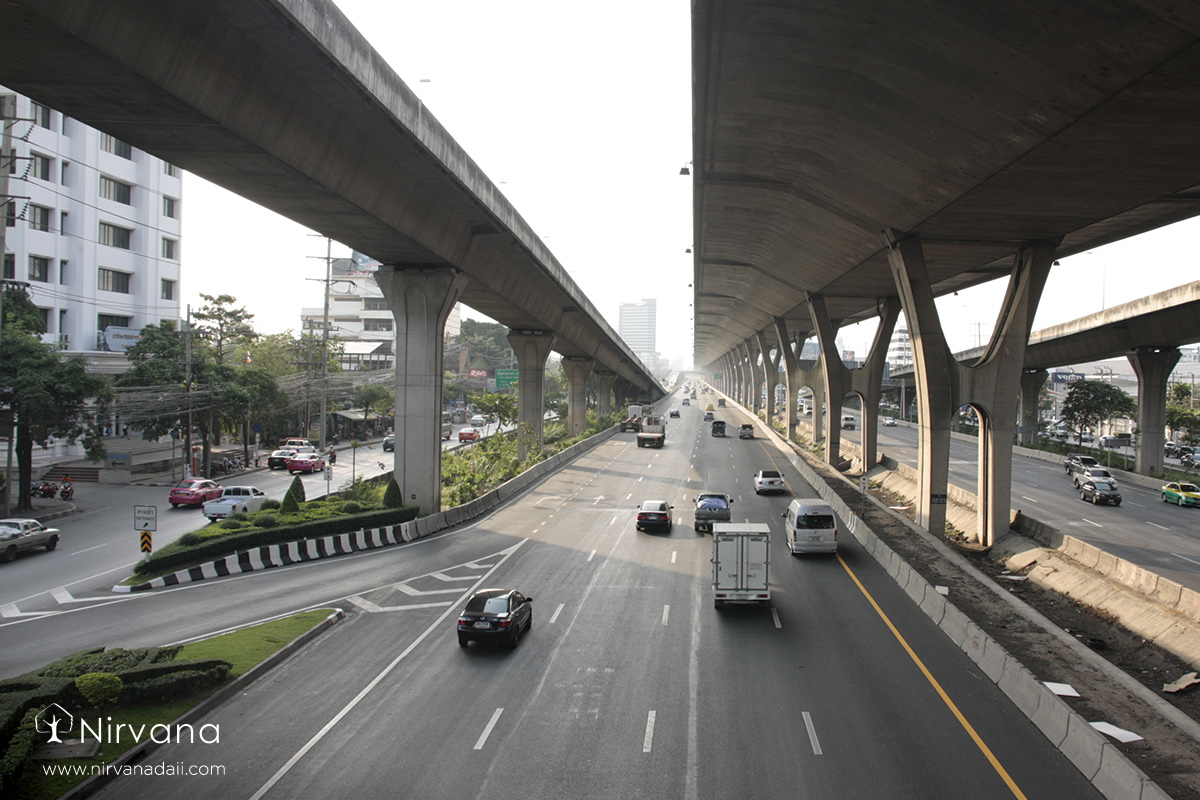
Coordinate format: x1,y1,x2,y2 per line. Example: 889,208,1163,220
0,0,662,510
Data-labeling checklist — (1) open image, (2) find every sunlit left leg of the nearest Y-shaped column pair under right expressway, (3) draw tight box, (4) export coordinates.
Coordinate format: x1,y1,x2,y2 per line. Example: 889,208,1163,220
884,231,958,536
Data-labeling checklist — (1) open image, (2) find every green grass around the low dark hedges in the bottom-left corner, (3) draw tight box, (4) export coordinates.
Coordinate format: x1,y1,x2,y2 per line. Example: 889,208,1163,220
5,608,332,800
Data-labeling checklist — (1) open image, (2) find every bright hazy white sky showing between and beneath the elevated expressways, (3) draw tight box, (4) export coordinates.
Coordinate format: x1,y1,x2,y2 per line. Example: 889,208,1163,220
182,0,1200,371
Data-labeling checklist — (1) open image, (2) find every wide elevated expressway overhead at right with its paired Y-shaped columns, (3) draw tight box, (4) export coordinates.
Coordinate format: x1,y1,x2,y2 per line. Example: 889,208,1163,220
692,0,1200,542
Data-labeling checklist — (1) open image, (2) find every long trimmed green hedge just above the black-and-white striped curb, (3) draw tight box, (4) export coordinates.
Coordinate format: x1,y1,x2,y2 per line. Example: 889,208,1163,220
134,506,419,575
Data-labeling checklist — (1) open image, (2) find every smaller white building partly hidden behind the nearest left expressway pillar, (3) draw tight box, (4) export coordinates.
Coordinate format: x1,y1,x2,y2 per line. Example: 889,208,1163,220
300,252,462,369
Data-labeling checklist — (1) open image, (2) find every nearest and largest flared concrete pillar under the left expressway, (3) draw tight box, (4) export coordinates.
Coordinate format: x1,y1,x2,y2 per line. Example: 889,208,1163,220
376,265,467,515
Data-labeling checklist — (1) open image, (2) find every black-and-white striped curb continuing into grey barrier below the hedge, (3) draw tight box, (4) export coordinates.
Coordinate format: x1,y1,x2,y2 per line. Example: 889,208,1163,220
113,426,618,593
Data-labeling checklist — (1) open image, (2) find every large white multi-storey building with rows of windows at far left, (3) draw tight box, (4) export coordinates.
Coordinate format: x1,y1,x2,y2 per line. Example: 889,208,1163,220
0,86,182,374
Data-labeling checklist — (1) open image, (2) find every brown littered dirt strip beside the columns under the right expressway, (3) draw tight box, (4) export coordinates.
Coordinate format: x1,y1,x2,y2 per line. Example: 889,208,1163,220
808,458,1200,800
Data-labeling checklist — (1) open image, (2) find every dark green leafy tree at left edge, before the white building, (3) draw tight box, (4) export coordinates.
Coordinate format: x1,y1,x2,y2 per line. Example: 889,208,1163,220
0,287,113,511
